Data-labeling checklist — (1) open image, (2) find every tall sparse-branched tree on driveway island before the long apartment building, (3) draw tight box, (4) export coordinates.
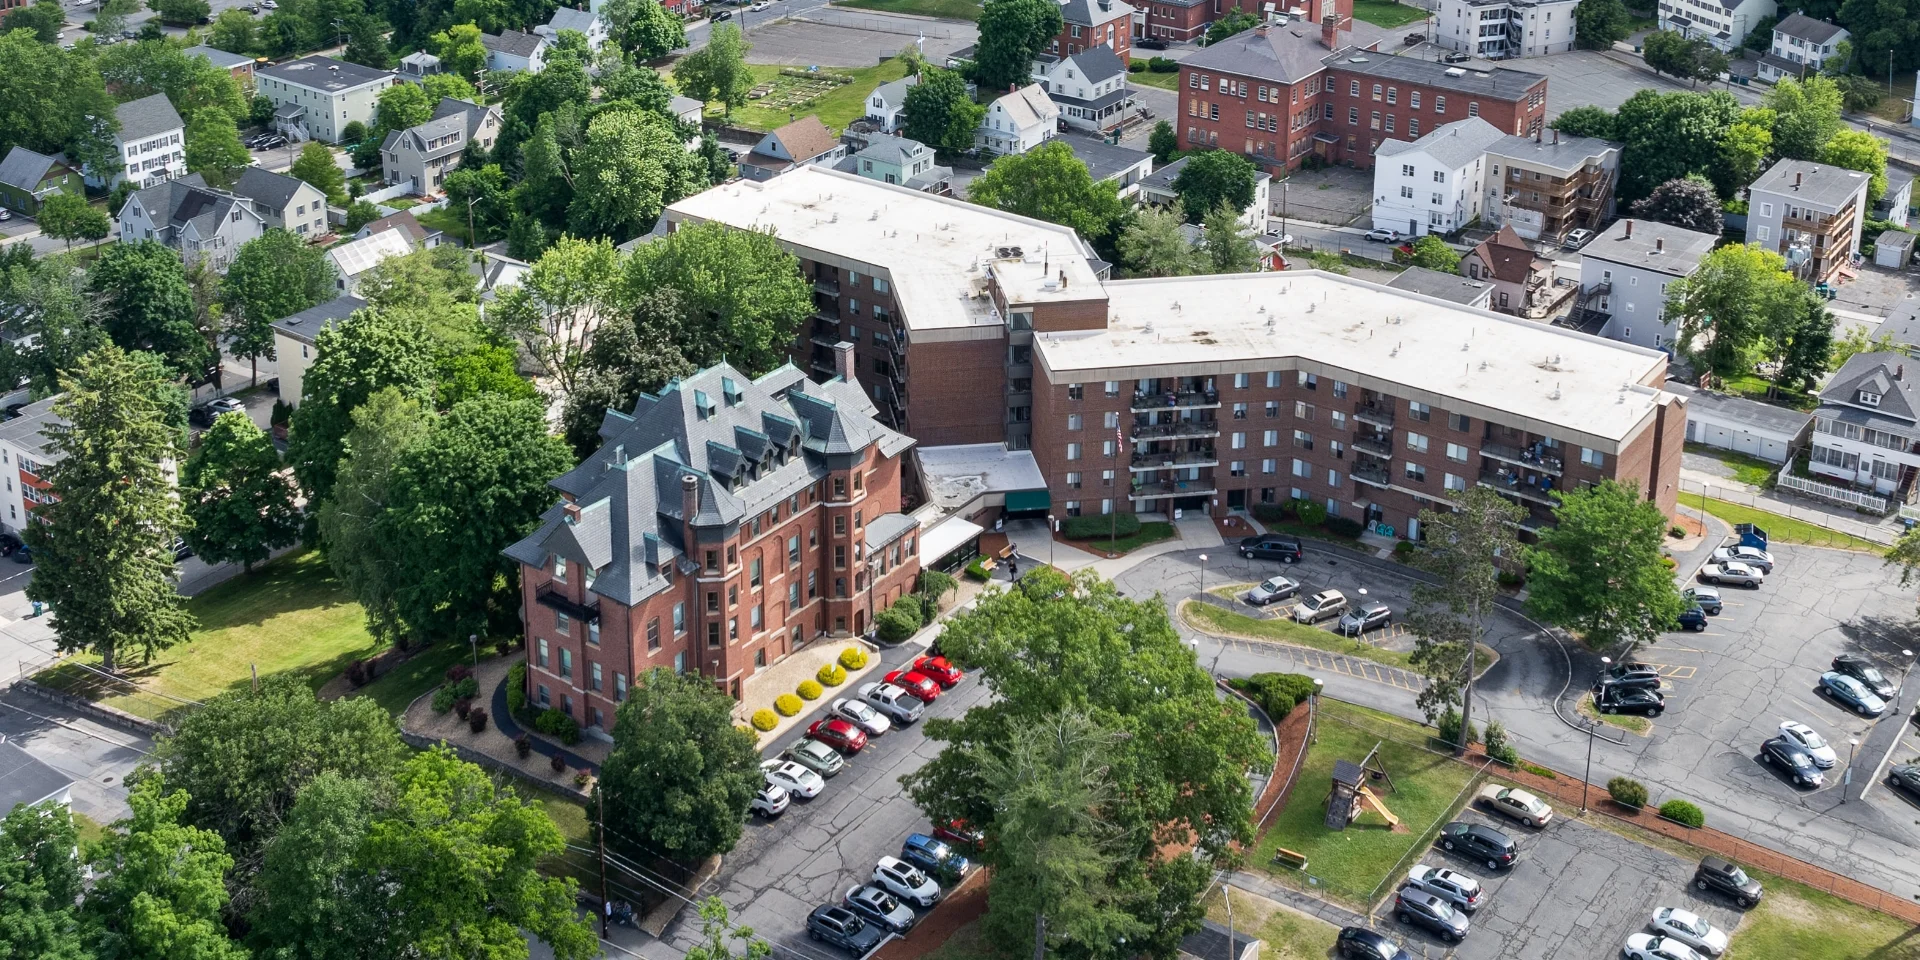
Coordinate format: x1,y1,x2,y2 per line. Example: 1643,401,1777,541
1405,486,1526,753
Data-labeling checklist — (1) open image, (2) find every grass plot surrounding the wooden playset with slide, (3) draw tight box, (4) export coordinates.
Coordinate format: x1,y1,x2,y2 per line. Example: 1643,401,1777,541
1248,699,1475,902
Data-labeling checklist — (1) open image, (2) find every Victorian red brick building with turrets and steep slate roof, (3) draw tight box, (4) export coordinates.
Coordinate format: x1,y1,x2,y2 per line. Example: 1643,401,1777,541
505,360,920,735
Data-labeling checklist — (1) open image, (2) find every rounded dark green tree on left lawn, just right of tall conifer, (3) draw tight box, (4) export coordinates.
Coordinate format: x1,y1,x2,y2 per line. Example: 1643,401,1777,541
180,413,300,570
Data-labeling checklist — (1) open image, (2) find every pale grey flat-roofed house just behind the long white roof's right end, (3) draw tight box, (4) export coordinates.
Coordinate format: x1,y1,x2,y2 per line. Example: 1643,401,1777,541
1569,219,1720,349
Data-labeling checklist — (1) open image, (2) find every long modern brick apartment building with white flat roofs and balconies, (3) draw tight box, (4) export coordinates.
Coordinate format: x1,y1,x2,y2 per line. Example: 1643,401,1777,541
666,169,1686,536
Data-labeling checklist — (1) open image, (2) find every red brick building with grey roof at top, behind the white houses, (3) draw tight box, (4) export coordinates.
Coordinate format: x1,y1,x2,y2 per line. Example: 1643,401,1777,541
1173,0,1548,175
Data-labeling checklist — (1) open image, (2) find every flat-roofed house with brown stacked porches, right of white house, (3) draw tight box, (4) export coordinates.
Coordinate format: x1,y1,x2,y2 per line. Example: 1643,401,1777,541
1482,131,1620,244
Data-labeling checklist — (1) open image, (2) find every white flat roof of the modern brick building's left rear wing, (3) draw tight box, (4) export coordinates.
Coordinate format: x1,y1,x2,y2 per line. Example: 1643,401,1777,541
666,165,1102,330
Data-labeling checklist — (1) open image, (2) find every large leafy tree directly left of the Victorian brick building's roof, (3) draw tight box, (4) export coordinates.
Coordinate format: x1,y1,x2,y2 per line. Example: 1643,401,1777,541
386,396,574,639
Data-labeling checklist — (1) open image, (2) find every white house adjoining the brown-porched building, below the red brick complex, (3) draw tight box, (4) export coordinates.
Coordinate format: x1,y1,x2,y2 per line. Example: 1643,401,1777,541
1373,117,1505,236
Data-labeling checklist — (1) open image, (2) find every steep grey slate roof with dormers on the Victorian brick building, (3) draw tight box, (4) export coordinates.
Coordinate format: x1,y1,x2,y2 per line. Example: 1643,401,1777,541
503,363,914,605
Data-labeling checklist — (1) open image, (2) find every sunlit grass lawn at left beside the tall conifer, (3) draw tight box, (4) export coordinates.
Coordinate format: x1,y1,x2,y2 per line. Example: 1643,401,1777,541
36,551,378,716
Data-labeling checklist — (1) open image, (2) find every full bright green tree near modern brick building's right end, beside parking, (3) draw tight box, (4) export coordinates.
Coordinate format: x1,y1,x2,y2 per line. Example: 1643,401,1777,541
1526,480,1686,660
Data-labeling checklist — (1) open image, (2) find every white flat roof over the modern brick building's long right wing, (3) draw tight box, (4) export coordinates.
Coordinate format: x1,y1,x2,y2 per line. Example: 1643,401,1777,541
1033,271,1667,444
